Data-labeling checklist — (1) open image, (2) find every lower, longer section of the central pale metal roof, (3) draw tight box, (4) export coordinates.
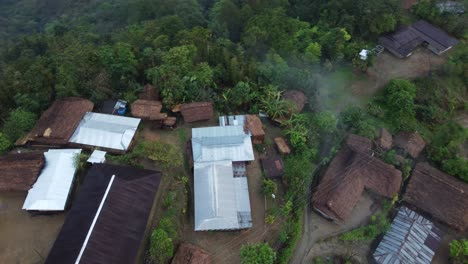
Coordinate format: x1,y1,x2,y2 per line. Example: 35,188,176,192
194,161,252,231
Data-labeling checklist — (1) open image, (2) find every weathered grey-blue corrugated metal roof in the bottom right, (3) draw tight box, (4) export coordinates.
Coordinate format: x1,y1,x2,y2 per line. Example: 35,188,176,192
373,207,442,264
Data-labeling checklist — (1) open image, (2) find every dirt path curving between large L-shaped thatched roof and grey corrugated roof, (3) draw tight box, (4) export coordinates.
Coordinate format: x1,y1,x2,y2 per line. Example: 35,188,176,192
290,193,380,264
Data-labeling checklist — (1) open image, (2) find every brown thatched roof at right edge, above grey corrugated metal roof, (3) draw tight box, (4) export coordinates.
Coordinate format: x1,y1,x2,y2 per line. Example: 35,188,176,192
403,163,468,231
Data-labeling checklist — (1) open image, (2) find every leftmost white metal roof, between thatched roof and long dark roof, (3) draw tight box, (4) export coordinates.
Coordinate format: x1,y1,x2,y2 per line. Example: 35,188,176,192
23,149,81,211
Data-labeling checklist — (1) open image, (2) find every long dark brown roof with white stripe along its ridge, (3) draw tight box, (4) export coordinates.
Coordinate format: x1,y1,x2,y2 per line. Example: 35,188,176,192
45,164,162,264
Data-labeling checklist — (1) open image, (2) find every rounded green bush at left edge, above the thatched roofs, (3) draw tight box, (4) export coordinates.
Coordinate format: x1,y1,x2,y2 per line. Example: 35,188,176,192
3,108,36,142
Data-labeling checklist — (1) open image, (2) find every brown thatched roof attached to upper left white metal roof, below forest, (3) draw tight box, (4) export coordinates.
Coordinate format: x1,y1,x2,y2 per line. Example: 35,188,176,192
26,97,94,145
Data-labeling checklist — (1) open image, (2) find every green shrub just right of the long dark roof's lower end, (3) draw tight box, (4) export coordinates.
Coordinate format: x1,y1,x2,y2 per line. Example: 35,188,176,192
150,228,174,263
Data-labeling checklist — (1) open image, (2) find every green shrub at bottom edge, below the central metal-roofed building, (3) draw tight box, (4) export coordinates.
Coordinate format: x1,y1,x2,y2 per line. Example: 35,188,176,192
240,243,276,264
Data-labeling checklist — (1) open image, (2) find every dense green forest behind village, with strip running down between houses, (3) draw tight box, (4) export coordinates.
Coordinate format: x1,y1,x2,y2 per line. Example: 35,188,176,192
0,0,468,262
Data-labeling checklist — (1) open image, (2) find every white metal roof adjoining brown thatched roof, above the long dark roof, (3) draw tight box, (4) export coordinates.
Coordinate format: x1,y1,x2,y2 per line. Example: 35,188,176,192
70,112,141,151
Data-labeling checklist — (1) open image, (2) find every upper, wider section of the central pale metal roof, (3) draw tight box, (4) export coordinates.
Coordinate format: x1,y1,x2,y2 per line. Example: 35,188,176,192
192,126,255,162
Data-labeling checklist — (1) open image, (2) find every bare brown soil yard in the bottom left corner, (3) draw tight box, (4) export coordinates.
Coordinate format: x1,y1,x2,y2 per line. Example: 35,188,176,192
0,192,66,264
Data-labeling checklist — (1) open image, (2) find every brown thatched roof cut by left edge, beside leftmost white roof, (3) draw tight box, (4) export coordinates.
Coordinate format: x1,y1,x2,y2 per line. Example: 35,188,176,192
0,152,45,191
